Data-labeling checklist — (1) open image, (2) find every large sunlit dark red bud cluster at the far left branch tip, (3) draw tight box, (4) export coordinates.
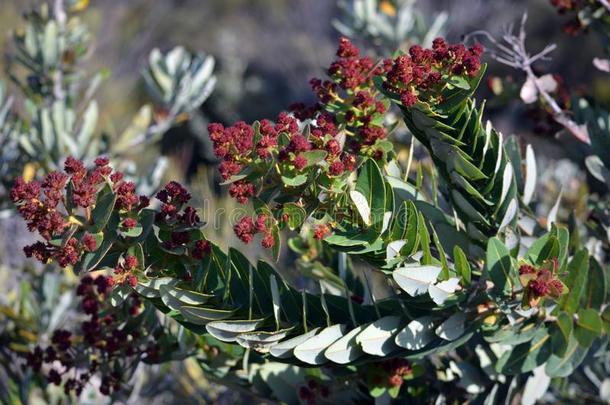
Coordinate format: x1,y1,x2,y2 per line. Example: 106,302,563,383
11,157,148,267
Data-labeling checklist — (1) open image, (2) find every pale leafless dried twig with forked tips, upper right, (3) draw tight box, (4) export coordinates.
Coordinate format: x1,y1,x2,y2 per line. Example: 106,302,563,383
468,13,588,144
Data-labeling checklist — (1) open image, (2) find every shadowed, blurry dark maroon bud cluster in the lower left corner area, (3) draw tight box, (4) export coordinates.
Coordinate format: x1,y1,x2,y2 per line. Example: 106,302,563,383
26,275,162,396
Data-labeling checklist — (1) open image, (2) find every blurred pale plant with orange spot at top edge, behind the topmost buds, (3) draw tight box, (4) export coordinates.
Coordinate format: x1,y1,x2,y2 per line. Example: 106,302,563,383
333,0,448,56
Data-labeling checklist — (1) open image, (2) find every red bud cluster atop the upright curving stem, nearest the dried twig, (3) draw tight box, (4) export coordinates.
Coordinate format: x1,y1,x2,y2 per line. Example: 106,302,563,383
384,38,483,107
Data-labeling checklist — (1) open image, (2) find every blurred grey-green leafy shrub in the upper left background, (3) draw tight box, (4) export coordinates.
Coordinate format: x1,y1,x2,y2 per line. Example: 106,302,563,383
0,1,215,211
